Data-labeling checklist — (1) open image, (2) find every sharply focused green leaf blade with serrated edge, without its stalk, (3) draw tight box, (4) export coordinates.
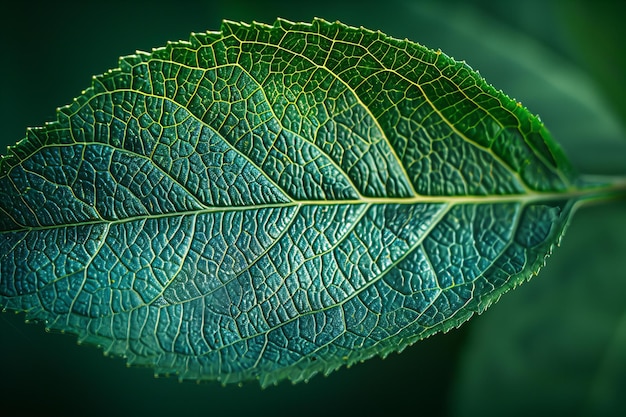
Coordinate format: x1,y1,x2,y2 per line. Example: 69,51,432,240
0,20,596,385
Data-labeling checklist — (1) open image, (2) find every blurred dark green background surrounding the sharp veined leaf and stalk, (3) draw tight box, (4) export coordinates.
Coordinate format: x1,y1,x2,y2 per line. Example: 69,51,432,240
0,0,626,416
